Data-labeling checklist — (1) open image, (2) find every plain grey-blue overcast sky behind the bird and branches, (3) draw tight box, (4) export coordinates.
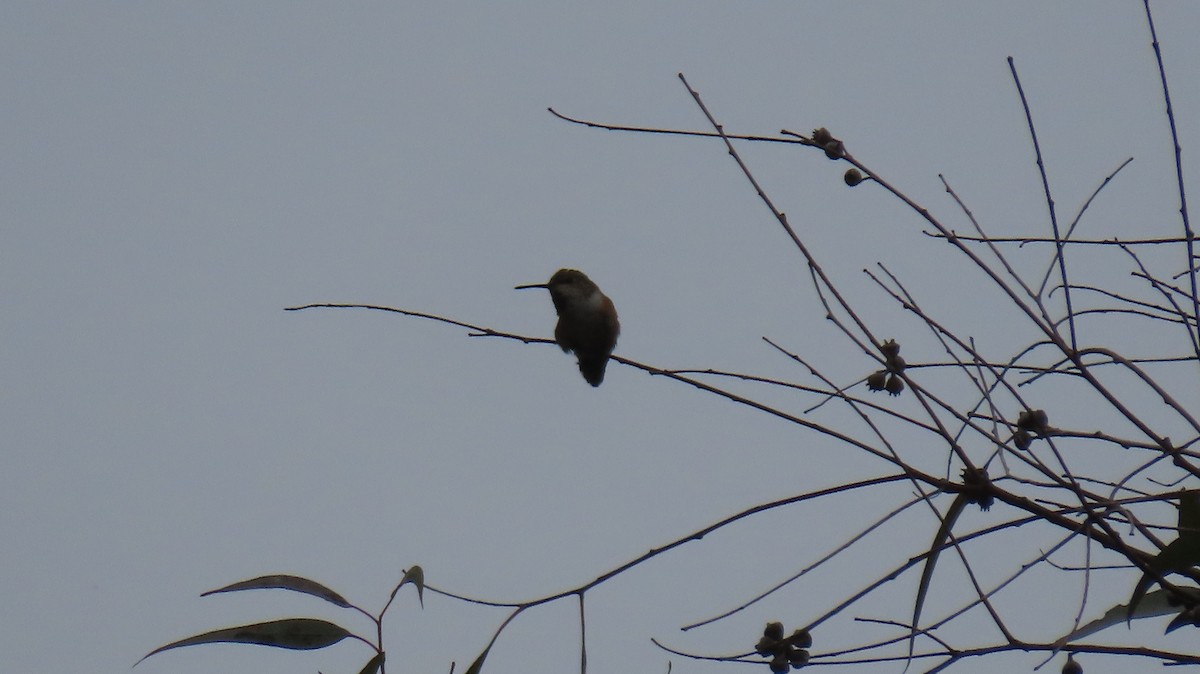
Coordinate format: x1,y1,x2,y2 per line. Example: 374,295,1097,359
0,0,1200,674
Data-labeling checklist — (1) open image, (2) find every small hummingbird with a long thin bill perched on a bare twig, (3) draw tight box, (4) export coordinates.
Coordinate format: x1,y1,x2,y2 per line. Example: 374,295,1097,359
516,269,620,386
